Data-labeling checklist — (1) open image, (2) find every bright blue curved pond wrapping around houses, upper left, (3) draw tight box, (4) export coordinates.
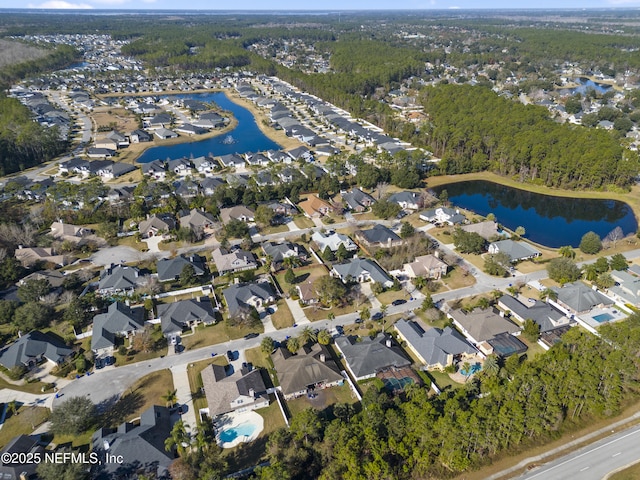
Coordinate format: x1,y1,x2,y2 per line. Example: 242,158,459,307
137,92,282,163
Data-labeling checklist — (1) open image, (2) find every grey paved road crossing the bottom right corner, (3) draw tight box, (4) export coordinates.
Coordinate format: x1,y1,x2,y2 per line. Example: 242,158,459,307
513,426,640,480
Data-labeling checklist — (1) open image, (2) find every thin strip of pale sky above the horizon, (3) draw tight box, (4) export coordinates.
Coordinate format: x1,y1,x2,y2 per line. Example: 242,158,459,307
0,0,640,11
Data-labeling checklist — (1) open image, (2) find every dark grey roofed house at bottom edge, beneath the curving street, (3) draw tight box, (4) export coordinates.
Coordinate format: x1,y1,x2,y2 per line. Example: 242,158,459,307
91,405,175,480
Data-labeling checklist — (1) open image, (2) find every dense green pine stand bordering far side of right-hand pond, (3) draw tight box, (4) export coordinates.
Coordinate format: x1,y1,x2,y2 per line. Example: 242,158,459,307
422,85,639,189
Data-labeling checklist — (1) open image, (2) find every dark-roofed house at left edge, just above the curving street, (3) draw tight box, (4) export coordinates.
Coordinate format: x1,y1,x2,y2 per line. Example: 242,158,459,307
0,330,73,370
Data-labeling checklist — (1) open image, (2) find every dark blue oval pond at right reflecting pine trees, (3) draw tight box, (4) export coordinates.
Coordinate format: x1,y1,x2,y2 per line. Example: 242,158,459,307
433,180,638,248
